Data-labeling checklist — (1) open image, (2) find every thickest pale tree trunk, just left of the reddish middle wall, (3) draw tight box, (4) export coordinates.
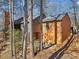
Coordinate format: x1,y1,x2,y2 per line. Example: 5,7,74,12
27,0,34,59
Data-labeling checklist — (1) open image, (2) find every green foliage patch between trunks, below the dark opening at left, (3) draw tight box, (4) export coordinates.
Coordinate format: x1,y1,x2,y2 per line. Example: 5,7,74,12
14,30,22,52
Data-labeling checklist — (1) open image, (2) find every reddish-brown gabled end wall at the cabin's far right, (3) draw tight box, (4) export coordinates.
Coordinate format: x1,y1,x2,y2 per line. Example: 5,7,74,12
62,15,71,42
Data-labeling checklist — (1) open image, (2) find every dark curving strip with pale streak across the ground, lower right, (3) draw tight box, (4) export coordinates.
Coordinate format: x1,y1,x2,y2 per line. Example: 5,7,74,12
49,35,74,59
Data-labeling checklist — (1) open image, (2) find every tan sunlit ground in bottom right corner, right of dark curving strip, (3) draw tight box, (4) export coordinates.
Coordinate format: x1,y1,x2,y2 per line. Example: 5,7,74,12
61,33,79,59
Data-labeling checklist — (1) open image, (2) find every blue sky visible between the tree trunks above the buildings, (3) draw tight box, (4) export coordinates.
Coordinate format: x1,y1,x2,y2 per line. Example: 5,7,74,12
0,0,79,29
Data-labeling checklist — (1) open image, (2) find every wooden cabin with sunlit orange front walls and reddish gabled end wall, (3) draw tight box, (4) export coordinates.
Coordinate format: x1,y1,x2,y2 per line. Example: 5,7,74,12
14,13,71,44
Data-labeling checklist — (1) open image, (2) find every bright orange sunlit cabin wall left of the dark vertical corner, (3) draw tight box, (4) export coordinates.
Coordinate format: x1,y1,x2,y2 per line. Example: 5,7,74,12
43,22,55,44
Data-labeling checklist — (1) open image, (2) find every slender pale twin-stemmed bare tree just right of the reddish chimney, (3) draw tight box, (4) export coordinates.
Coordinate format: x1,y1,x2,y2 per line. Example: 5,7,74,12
9,0,17,59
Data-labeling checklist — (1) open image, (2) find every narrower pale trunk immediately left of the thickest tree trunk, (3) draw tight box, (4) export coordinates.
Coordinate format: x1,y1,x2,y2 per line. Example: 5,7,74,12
22,0,28,59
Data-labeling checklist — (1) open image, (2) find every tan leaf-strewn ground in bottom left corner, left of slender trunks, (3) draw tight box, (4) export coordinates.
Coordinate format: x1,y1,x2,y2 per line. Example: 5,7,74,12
0,32,12,59
